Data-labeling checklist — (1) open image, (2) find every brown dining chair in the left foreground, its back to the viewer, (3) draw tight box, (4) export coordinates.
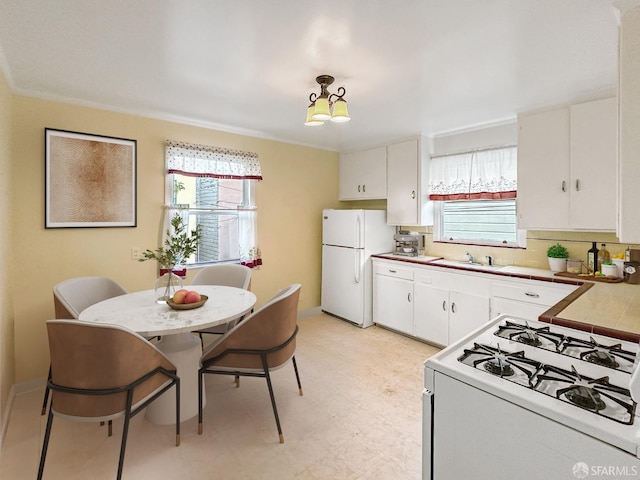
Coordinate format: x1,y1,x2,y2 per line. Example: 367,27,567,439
38,320,180,480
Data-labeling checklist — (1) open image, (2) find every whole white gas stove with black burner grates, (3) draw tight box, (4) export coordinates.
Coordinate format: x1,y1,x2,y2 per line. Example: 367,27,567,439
422,315,640,480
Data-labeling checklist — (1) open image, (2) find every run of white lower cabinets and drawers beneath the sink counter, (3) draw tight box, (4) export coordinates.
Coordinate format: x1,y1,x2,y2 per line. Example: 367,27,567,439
373,258,578,346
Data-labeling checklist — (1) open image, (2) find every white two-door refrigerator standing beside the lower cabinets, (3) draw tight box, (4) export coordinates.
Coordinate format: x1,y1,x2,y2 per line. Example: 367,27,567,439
321,210,395,328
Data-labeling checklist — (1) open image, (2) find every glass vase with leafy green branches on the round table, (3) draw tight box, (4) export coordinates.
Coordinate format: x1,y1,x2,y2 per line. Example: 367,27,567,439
138,213,202,302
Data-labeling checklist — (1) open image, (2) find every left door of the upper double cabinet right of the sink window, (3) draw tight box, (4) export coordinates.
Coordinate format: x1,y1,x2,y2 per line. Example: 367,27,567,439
517,108,569,229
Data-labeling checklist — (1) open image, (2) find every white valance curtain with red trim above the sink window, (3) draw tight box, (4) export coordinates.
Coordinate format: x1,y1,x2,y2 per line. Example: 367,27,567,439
429,147,518,200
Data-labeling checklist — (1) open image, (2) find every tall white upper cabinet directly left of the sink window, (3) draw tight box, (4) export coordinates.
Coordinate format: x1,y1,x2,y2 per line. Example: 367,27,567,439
387,139,433,226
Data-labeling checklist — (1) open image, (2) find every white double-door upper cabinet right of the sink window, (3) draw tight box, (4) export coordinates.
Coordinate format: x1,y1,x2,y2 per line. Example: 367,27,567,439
517,98,617,231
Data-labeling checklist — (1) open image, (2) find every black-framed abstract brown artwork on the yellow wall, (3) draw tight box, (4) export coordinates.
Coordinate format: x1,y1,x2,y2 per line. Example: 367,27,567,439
45,128,137,228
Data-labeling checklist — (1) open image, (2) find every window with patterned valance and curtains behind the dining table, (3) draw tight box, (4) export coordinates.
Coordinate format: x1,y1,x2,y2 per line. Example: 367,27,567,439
166,141,262,268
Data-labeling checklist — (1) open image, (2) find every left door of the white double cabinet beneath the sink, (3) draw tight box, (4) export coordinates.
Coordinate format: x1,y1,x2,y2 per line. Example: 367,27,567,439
413,282,449,346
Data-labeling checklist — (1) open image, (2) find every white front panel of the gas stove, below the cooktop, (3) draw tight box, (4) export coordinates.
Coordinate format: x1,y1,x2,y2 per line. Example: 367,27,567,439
430,372,640,480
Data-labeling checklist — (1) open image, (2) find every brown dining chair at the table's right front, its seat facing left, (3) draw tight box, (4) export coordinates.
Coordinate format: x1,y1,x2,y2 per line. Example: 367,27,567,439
198,284,302,443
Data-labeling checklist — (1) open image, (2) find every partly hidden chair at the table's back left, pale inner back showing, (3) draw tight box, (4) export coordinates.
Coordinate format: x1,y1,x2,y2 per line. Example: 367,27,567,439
42,277,127,416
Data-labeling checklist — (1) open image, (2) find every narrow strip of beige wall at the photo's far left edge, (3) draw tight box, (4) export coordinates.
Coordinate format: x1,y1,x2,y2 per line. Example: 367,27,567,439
0,62,15,447
